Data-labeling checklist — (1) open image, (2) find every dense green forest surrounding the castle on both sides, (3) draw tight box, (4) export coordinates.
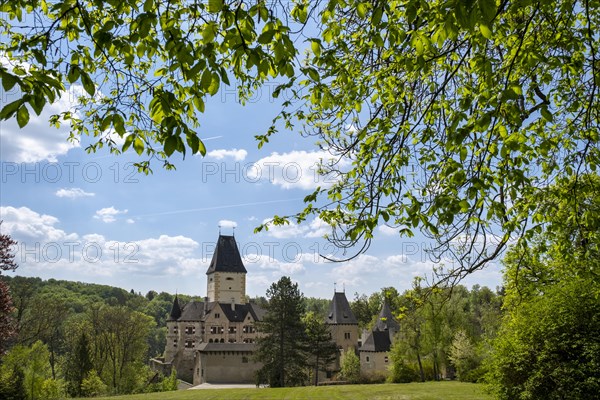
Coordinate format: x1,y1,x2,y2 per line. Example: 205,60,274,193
1,276,502,399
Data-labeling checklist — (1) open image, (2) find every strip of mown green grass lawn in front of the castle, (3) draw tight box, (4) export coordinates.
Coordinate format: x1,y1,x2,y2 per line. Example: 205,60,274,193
88,382,492,400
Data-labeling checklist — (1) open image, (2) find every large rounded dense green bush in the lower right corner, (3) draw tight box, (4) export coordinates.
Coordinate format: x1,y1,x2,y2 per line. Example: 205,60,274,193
487,280,600,400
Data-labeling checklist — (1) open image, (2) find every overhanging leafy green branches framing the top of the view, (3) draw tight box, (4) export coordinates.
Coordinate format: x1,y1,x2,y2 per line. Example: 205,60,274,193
0,0,600,279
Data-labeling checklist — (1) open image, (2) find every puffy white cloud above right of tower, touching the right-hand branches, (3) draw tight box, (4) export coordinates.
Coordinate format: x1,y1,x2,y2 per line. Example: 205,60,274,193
246,151,349,189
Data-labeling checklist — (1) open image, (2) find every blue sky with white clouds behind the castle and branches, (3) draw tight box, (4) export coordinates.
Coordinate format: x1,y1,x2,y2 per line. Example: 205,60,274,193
0,76,501,298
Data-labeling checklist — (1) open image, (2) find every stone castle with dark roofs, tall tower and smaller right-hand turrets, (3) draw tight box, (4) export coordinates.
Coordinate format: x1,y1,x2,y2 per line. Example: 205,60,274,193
151,235,397,385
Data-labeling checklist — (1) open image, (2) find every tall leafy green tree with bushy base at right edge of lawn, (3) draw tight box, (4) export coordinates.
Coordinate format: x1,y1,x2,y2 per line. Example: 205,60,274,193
490,175,600,400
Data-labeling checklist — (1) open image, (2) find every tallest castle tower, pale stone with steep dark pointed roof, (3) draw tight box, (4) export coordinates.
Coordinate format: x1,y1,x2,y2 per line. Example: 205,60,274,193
206,235,247,304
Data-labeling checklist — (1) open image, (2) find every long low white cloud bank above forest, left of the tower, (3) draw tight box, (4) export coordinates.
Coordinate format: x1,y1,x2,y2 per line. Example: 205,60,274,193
0,203,208,278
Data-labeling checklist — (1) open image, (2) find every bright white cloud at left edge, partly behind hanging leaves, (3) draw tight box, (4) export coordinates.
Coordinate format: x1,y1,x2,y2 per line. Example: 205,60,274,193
0,83,83,163
